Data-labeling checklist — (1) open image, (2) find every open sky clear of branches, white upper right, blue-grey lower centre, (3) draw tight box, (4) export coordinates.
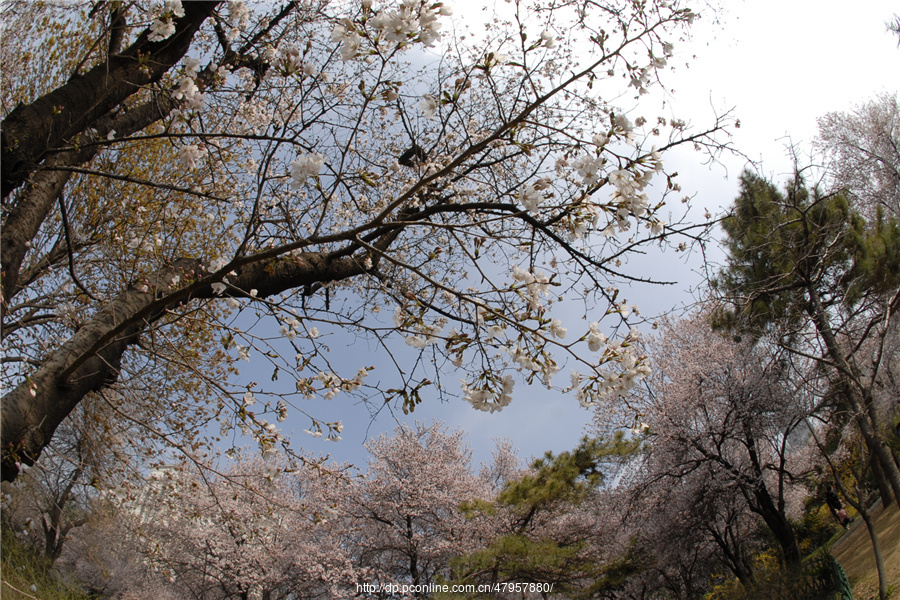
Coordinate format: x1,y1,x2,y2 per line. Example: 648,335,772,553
284,0,900,466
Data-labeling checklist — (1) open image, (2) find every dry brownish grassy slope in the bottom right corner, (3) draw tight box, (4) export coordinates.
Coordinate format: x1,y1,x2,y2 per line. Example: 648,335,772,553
831,503,900,600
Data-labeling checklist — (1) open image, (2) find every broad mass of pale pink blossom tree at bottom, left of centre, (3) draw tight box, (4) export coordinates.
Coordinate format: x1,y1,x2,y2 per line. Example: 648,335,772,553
85,457,359,600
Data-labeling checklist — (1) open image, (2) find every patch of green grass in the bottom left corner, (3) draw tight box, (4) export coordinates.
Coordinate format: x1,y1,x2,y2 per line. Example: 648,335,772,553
0,529,90,600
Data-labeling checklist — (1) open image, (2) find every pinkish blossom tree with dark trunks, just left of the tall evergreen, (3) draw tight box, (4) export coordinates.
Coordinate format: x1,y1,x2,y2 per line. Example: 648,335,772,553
601,312,811,568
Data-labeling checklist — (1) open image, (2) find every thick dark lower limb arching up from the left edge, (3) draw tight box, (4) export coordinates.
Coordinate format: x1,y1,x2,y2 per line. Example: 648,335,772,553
2,250,372,481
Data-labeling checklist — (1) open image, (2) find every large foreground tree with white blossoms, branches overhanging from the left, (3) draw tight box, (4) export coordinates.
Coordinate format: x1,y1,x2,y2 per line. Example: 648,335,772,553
0,0,728,479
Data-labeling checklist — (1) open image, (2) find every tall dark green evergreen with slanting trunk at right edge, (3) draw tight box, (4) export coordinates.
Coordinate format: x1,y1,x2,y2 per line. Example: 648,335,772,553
713,172,900,504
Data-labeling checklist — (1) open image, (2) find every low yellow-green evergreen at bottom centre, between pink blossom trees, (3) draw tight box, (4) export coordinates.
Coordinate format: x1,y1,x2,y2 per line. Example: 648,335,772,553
444,432,640,598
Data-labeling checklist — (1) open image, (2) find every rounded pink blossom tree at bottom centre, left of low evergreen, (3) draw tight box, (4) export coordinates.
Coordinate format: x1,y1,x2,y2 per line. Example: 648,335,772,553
335,423,496,598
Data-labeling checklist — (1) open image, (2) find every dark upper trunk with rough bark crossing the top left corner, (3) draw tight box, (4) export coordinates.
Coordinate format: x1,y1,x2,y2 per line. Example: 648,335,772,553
0,3,202,315
